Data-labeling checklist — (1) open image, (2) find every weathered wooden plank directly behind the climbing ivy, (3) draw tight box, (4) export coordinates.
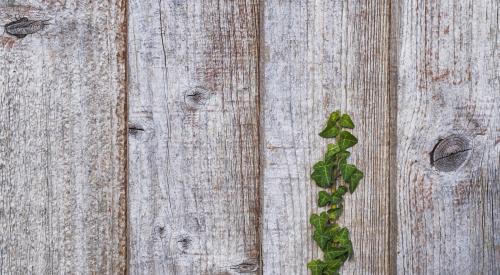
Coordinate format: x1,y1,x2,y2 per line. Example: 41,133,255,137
262,0,391,274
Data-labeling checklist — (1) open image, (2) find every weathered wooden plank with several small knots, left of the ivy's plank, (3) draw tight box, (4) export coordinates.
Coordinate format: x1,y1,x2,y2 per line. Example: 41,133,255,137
129,0,260,274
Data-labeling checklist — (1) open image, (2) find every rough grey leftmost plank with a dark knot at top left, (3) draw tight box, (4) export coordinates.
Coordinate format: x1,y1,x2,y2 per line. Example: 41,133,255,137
0,0,127,274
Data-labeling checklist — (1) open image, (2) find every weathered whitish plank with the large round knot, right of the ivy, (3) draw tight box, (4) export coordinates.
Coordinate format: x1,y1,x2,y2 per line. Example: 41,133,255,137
393,0,500,274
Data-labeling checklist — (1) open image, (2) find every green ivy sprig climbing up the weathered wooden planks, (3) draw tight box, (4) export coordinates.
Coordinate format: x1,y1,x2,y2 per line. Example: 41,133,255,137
307,111,363,275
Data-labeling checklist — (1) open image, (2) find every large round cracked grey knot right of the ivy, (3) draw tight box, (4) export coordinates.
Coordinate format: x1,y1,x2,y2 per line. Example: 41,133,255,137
431,135,472,172
